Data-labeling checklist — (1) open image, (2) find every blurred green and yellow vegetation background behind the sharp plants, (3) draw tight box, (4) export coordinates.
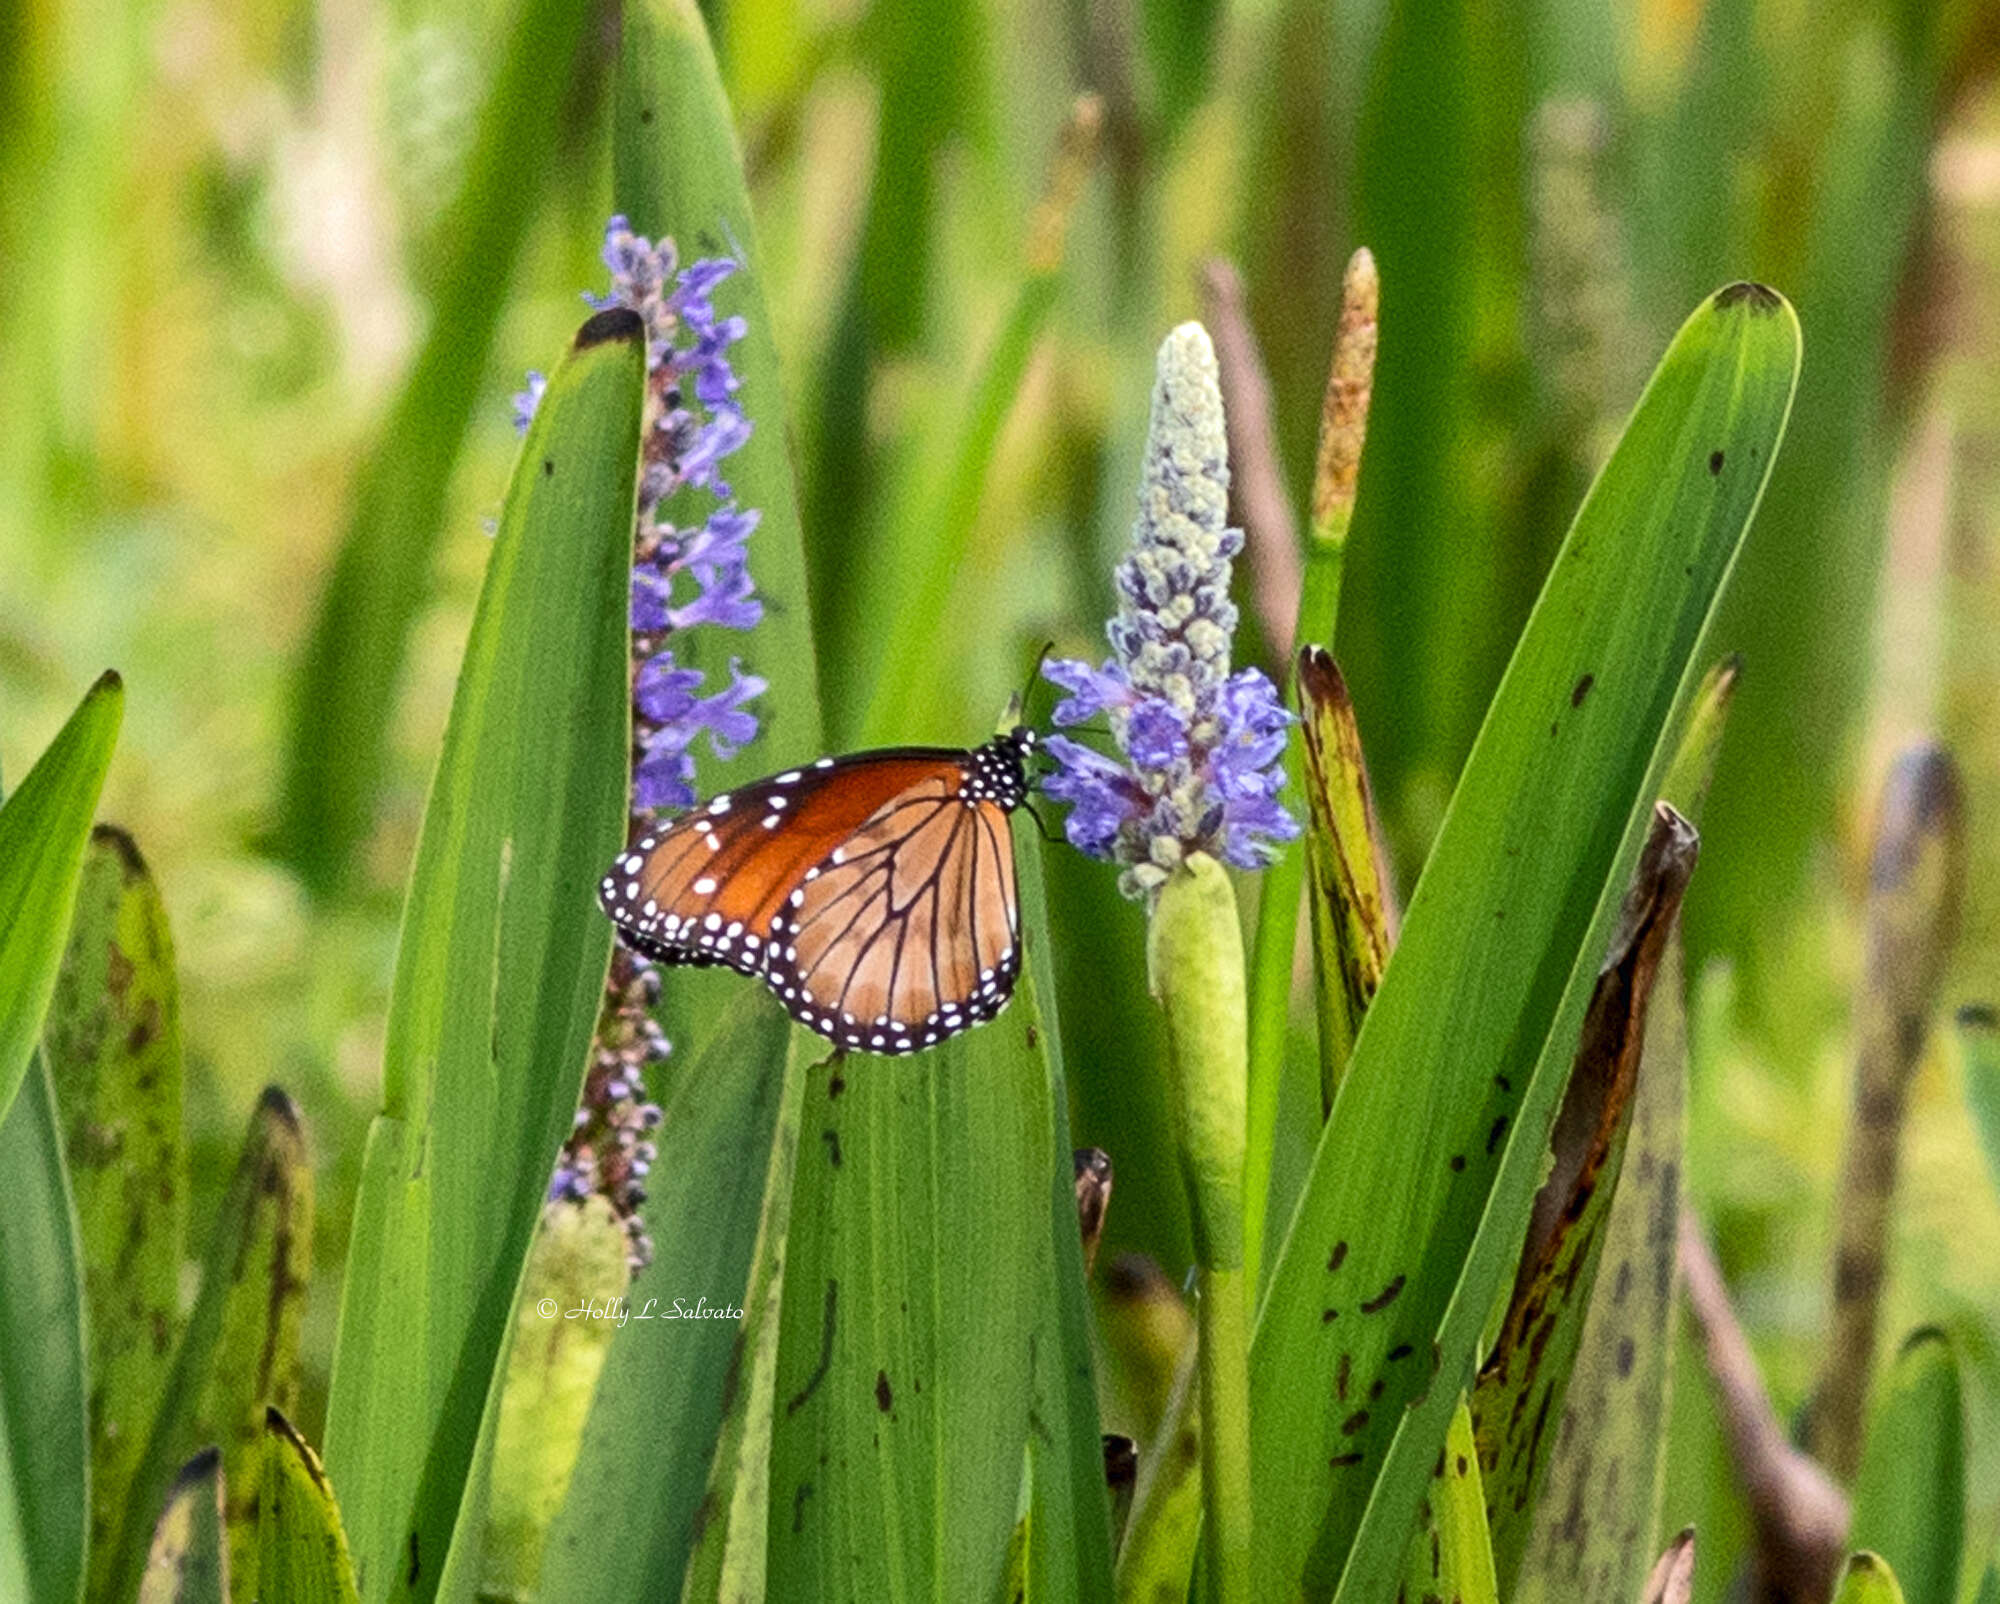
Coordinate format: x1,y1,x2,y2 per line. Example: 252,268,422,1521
0,0,2000,1592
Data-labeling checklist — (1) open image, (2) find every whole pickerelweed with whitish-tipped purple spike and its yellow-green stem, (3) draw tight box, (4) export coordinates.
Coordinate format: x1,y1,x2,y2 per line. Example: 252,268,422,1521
1042,324,1272,1604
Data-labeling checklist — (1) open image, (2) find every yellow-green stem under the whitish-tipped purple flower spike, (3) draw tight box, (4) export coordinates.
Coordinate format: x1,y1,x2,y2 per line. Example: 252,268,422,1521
1146,852,1250,1604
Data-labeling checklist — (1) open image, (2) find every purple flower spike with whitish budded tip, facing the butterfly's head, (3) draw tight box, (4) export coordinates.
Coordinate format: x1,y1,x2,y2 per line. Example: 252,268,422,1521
1042,324,1298,896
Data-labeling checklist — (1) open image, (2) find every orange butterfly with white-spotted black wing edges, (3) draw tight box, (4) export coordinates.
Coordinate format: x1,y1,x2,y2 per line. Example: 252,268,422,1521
598,726,1034,1054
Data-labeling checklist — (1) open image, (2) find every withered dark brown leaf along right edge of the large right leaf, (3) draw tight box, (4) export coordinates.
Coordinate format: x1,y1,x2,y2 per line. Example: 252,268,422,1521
1472,804,1696,1596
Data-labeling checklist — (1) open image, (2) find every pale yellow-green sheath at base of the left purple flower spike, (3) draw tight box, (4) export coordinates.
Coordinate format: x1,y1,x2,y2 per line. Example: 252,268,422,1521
476,1198,632,1598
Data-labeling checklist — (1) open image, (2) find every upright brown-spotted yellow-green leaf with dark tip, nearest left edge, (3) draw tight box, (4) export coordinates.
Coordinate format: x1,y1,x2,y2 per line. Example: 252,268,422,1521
44,824,188,1584
